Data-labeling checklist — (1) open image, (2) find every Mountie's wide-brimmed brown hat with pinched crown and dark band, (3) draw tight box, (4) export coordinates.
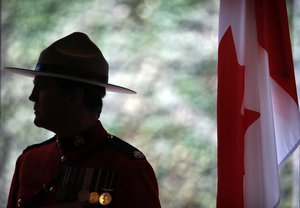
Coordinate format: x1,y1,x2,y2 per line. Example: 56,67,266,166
4,32,136,94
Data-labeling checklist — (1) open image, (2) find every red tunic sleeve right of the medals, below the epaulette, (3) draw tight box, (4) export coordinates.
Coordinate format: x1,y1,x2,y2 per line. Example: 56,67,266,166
114,160,161,208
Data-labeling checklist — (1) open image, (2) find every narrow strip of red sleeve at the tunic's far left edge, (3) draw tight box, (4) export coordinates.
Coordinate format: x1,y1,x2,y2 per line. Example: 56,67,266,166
7,157,21,208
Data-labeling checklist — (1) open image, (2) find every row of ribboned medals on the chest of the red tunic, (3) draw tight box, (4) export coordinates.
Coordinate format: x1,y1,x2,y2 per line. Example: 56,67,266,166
58,166,116,206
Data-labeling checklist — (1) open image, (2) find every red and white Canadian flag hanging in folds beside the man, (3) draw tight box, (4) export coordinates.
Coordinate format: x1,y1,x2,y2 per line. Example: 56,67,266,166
217,0,300,208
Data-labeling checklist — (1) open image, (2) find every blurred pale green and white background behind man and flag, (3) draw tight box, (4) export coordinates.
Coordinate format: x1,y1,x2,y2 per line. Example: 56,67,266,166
0,0,300,208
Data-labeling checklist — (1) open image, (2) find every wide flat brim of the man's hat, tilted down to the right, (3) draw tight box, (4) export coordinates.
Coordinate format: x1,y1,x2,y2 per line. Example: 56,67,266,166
4,67,136,94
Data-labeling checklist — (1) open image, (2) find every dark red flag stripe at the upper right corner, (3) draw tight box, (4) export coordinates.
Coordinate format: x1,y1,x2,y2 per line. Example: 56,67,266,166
255,0,298,104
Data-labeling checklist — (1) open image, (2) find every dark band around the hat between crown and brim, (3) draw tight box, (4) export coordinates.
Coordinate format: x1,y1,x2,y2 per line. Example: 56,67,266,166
34,63,108,84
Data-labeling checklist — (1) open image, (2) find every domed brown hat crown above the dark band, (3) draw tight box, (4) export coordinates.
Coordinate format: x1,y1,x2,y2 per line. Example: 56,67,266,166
38,32,109,76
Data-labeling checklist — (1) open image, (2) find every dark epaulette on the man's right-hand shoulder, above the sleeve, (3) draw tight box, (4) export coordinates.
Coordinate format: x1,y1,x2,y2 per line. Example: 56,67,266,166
109,135,146,160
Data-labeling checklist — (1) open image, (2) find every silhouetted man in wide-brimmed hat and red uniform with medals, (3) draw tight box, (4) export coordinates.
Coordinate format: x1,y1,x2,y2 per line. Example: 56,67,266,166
5,32,160,208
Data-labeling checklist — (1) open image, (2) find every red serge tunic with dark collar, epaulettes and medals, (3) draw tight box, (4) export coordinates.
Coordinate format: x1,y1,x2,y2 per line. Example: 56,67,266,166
7,122,160,208
